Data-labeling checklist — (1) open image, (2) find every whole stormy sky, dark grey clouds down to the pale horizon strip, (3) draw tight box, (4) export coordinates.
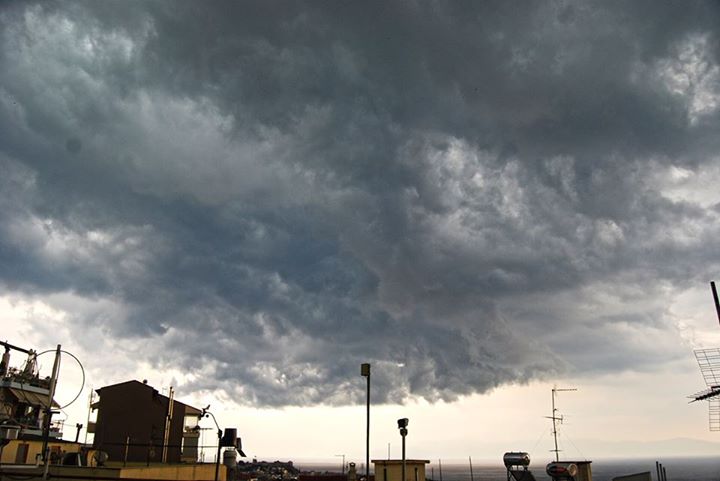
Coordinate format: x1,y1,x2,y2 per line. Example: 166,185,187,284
0,1,720,462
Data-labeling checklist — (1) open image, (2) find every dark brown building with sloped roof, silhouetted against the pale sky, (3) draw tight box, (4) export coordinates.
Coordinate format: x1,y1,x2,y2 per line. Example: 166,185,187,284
92,381,202,463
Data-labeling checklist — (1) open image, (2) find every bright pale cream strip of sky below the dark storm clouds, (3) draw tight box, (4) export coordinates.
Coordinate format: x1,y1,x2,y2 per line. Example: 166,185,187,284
0,295,720,460
